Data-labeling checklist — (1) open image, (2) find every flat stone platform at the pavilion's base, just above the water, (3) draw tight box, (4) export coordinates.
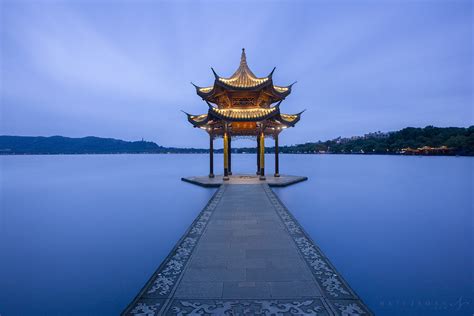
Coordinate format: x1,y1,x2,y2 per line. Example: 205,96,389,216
181,174,308,188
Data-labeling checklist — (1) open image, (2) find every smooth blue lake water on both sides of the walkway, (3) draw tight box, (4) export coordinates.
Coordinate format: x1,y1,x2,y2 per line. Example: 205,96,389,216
0,154,474,316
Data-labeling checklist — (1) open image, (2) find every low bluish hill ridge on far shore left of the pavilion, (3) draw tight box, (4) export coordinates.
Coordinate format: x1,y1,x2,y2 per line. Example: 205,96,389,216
0,136,206,155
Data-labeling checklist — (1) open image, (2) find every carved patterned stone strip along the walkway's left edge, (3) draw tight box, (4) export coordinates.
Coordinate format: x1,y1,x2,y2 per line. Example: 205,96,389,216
122,185,226,316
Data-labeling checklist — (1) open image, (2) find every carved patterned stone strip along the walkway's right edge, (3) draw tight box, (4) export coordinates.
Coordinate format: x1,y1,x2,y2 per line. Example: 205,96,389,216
262,184,372,315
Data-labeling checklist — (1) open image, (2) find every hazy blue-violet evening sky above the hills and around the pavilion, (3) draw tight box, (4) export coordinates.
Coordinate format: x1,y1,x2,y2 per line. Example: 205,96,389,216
0,0,473,147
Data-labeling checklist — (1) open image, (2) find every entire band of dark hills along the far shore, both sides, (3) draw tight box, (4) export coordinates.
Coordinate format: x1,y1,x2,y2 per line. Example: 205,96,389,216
0,126,474,156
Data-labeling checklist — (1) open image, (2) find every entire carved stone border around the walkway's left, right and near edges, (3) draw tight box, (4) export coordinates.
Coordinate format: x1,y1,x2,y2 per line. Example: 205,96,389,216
122,184,373,316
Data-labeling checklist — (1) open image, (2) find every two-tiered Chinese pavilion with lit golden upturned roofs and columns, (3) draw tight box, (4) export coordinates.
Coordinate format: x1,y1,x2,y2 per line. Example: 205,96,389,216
186,49,302,180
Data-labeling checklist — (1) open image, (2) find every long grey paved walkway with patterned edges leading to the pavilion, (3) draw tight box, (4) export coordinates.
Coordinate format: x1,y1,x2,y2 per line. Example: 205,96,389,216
124,184,371,315
